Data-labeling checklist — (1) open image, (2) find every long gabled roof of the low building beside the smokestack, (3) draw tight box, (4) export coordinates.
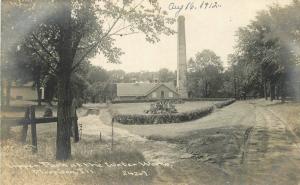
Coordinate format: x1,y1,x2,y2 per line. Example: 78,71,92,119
117,83,177,96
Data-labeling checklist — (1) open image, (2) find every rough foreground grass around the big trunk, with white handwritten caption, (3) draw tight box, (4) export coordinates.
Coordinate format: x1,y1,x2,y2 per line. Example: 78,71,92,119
0,123,156,185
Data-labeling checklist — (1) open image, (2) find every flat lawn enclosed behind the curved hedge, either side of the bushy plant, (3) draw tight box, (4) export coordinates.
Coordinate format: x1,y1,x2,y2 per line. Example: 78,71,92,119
111,101,216,114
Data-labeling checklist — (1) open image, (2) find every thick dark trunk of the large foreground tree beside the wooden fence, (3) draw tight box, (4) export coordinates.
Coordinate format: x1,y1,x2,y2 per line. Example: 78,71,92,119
56,0,73,160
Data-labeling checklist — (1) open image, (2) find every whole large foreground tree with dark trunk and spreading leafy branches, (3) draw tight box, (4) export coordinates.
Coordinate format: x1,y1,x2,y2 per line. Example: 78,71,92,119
3,0,175,160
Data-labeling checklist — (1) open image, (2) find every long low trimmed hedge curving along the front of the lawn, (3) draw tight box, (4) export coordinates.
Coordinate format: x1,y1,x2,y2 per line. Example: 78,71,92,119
114,106,214,125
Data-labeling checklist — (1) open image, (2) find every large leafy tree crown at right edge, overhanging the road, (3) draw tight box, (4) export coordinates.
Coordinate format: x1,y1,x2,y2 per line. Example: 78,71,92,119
232,1,300,100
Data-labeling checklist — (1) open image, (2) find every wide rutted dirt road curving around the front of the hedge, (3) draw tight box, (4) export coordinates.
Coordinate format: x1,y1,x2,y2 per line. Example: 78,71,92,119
81,100,300,185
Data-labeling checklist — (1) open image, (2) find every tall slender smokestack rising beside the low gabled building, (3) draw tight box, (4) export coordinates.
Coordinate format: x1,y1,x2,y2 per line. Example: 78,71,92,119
177,16,188,98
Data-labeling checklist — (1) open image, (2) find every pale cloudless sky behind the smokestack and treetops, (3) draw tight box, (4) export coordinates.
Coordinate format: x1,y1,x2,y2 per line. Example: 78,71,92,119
91,0,292,72
